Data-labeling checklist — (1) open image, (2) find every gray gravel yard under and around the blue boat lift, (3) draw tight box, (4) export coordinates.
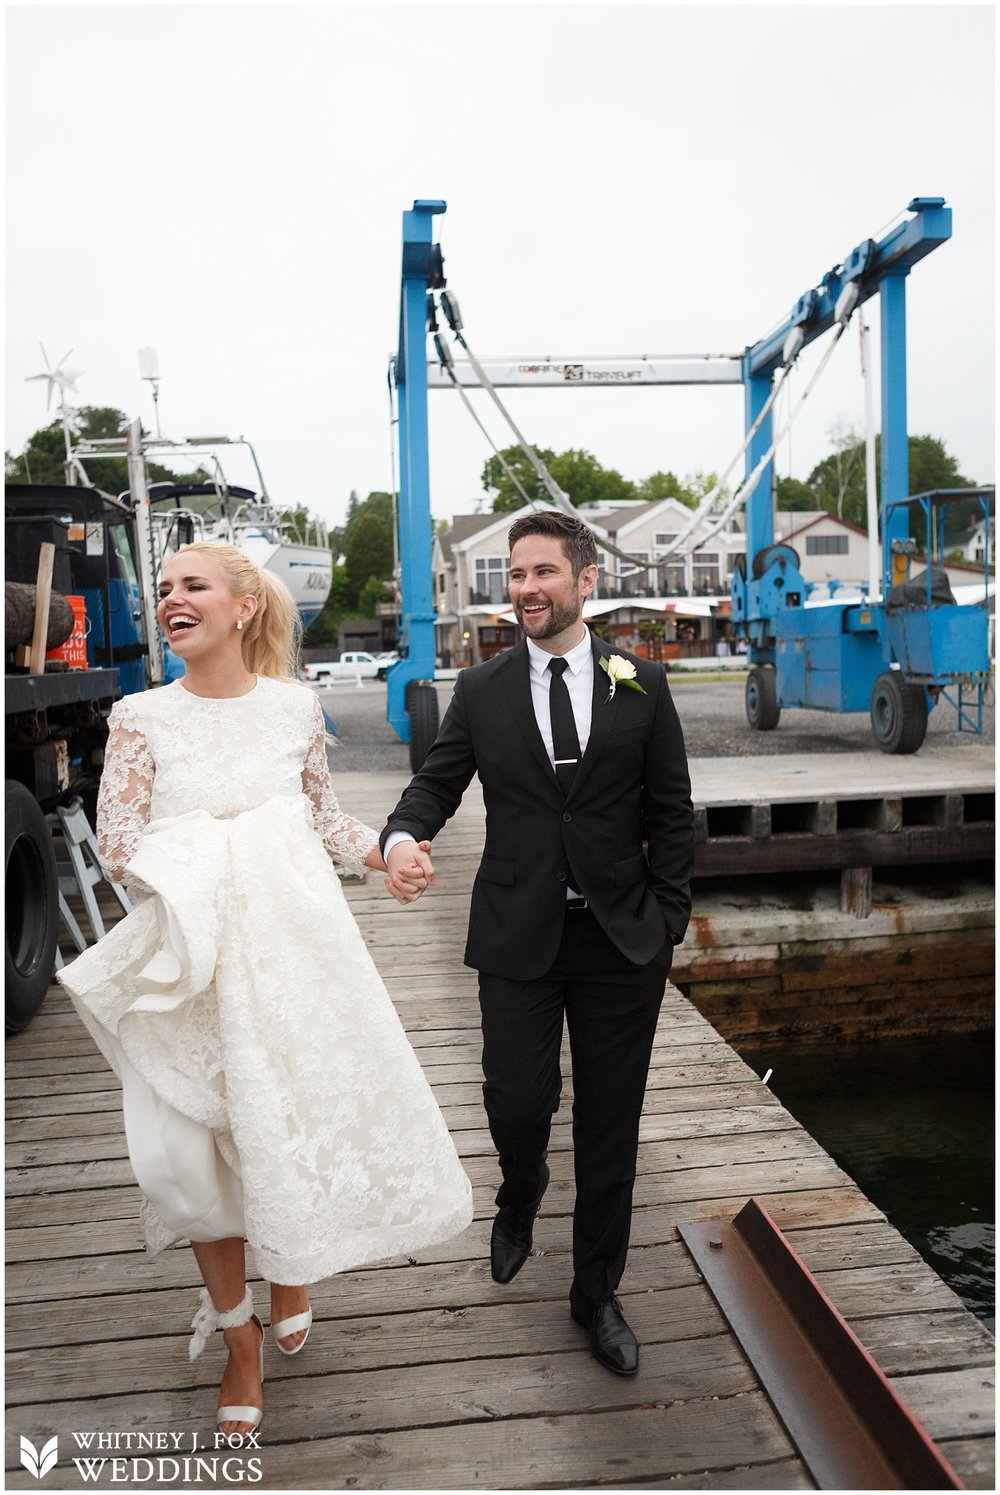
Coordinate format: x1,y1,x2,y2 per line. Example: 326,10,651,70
317,674,996,773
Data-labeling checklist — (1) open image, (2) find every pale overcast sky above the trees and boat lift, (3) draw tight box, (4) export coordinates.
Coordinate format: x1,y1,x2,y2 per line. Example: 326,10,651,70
6,4,994,522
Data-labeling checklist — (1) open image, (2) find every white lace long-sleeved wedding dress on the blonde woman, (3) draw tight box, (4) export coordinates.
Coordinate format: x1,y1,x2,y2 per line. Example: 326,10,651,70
60,677,472,1283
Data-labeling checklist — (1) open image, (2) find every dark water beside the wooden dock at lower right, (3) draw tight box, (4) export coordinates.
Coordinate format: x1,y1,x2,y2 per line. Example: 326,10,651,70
744,1033,996,1332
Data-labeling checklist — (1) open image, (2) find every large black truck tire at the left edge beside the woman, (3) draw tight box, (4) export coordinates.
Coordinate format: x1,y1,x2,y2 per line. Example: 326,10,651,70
4,779,58,1033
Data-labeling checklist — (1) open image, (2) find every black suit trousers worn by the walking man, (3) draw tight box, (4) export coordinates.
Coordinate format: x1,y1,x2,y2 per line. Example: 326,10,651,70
480,909,673,1299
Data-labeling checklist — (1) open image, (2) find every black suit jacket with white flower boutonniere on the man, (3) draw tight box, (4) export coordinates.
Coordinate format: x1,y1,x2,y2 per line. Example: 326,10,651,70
381,637,694,981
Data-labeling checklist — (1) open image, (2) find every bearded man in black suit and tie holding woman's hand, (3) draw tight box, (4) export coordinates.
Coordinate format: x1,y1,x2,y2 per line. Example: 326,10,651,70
381,511,694,1375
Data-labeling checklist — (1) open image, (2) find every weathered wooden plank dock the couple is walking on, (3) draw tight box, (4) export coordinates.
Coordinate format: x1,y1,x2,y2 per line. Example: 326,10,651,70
6,774,994,1491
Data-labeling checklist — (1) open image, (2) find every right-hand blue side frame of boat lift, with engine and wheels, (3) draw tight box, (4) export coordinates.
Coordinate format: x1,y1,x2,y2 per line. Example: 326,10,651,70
729,197,990,753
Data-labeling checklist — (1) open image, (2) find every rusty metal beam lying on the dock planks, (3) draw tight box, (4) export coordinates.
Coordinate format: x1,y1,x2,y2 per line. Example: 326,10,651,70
677,1199,966,1491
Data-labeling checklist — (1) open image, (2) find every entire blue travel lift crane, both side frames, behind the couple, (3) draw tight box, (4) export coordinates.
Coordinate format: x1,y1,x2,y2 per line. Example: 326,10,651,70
389,197,993,768
